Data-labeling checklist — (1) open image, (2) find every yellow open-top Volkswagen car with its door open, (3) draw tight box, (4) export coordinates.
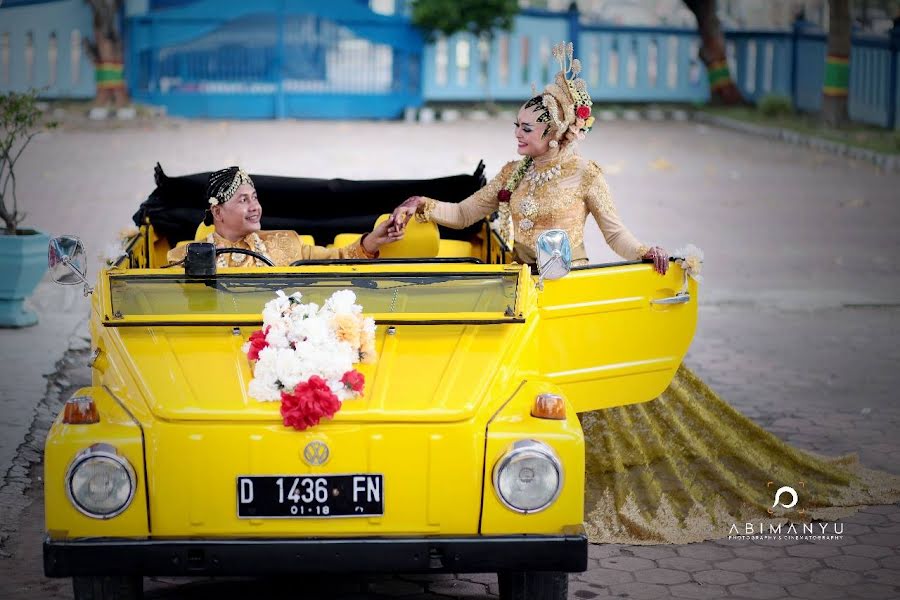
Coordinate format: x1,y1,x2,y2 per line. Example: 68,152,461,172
44,169,697,600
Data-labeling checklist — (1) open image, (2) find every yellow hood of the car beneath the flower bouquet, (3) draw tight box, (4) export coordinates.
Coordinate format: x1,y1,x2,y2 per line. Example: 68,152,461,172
114,323,523,422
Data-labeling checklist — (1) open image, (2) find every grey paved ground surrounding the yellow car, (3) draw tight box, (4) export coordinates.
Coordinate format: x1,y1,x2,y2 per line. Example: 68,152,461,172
0,115,900,599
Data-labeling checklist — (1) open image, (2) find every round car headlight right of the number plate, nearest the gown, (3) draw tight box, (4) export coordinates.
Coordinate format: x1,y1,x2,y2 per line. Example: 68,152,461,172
494,440,563,514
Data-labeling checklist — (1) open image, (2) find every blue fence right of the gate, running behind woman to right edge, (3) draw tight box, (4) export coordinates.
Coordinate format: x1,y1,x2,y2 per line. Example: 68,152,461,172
424,11,900,127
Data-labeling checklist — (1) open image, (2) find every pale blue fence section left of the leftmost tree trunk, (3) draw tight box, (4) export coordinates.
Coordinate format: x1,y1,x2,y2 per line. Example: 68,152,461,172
0,0,95,98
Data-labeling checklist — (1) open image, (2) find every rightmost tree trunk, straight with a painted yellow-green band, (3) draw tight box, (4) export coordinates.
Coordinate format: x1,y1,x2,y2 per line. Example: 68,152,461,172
822,0,850,126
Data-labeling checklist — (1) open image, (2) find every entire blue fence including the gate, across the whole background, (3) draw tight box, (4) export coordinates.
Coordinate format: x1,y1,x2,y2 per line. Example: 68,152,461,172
0,0,900,127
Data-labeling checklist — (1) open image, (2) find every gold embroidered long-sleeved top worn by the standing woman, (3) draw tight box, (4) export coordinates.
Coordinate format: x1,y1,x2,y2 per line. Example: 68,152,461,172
417,150,648,265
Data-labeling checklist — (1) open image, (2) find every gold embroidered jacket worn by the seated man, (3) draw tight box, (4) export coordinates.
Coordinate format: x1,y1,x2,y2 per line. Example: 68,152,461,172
167,230,376,267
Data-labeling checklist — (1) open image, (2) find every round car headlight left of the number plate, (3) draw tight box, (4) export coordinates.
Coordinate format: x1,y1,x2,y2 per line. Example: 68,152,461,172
66,444,136,519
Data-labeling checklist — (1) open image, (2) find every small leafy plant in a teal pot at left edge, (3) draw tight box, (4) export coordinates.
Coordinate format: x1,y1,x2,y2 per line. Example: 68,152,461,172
0,90,56,327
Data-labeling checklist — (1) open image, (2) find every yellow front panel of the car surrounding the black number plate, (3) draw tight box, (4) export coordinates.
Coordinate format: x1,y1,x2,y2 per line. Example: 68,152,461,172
148,422,484,537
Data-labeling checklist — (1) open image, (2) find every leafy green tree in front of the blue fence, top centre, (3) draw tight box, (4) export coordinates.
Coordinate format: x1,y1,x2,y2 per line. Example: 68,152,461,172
412,0,519,104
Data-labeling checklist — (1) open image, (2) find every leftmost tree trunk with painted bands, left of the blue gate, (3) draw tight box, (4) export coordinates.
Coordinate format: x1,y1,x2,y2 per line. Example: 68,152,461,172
85,0,128,108
